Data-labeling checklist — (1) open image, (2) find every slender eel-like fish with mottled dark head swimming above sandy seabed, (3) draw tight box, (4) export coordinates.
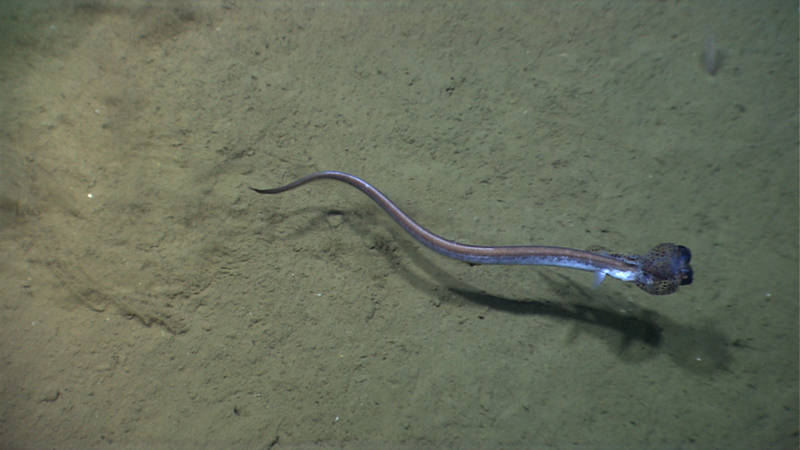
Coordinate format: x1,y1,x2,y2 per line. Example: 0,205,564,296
250,170,693,295
